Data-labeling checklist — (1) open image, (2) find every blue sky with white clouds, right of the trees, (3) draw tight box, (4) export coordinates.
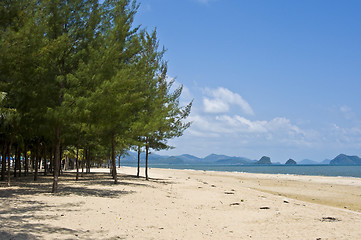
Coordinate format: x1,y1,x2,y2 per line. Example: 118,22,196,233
134,0,361,163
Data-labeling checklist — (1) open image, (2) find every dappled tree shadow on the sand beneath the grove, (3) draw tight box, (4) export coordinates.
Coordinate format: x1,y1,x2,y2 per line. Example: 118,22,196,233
0,170,171,240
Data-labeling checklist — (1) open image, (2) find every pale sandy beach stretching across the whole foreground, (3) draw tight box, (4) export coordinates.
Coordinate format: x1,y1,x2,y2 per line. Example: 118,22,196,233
0,167,361,240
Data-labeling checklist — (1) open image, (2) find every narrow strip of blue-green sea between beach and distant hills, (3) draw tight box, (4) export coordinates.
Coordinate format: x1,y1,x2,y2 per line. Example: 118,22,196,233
123,163,361,178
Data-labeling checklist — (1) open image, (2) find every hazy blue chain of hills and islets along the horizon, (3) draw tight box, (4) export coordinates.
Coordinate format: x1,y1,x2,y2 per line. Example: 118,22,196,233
120,152,361,165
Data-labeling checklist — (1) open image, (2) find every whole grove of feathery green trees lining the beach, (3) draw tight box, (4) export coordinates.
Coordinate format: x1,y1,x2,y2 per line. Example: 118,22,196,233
0,0,192,193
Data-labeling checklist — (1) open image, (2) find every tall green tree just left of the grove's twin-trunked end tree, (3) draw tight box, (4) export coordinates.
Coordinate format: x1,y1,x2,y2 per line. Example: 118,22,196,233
87,1,141,183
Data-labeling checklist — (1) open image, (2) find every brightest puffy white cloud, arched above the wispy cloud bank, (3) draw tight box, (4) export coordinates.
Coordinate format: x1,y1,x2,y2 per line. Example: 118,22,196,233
203,87,254,115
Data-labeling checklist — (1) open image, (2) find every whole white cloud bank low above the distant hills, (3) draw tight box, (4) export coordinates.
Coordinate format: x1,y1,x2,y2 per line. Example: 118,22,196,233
160,83,361,162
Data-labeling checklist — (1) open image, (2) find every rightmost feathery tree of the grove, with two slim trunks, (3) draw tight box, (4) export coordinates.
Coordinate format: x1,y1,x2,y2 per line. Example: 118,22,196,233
132,30,192,180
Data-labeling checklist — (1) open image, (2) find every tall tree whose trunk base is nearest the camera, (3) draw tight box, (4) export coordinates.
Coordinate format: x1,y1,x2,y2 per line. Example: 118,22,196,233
31,0,103,193
